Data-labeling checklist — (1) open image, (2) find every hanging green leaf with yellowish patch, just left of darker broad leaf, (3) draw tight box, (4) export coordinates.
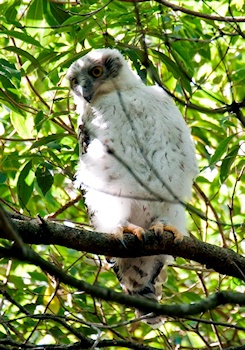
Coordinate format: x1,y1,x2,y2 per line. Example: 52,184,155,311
17,160,34,208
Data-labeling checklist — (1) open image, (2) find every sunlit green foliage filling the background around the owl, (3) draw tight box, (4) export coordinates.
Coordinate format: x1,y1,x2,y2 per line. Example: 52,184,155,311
0,0,245,349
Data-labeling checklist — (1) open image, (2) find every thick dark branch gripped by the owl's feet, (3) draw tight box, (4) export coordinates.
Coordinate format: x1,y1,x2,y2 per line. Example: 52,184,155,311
0,215,245,280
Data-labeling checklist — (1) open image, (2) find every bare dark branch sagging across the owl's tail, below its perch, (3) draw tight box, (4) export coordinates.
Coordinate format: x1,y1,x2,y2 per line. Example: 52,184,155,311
0,243,245,318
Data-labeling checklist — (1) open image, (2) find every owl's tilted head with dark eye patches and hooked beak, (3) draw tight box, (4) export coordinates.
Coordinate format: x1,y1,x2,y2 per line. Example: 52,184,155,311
67,49,139,102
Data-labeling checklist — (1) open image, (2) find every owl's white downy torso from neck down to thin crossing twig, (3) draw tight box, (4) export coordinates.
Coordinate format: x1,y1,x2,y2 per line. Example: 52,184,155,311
77,90,196,198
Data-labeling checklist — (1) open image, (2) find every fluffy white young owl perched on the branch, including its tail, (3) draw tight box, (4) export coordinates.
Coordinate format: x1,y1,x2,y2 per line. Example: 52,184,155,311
68,48,197,324
